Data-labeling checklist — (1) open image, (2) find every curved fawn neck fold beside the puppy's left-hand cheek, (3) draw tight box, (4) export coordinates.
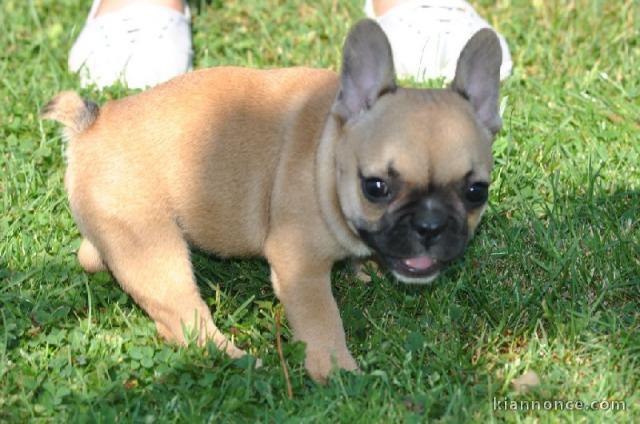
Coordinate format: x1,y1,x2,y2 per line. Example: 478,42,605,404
315,113,372,257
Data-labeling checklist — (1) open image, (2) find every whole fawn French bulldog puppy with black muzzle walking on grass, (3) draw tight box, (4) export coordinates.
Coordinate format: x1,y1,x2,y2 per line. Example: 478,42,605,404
43,20,501,381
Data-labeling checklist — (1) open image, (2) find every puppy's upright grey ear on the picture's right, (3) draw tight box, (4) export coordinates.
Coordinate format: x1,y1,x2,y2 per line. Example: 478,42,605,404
451,28,502,135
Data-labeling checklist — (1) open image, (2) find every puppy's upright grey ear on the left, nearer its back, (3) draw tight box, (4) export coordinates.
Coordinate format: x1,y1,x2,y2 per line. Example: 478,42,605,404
332,19,396,122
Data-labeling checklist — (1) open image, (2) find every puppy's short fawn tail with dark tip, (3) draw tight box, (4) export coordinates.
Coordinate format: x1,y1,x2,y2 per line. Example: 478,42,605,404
40,91,100,138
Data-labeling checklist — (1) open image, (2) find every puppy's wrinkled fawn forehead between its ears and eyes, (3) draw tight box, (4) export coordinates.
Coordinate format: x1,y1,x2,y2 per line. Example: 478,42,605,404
354,89,492,185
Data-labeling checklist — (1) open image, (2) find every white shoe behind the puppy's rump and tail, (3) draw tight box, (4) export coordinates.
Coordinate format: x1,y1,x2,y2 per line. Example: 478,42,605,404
69,0,193,88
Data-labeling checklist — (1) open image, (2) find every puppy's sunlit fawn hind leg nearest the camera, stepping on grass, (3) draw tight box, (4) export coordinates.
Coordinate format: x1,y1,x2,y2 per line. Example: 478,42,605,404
100,215,245,358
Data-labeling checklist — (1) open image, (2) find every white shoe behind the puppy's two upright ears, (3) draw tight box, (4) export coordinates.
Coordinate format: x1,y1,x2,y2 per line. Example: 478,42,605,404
365,0,513,81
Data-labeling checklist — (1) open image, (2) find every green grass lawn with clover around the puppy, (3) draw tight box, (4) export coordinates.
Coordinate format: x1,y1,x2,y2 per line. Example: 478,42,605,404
0,0,640,422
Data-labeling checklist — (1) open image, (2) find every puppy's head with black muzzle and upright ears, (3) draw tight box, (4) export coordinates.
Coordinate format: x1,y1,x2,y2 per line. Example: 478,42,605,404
332,20,502,283
